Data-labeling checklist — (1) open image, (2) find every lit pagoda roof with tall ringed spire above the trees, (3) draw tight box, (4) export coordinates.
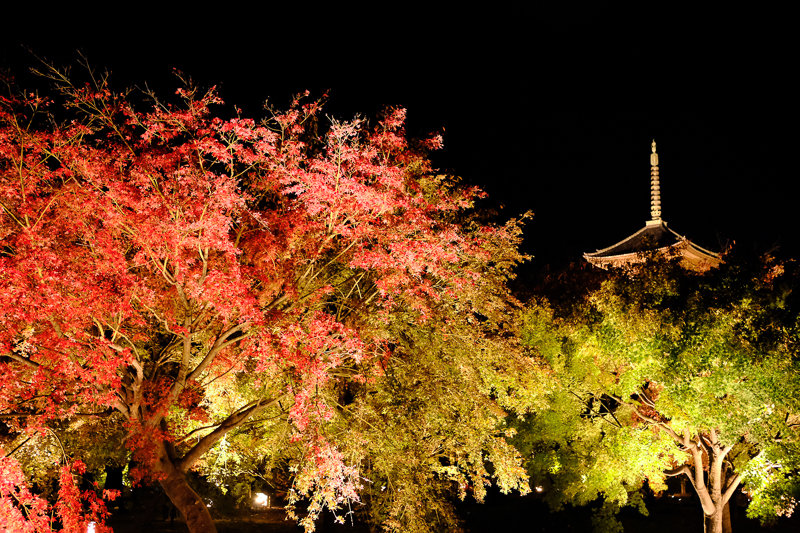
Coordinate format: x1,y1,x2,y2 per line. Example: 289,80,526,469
583,141,721,272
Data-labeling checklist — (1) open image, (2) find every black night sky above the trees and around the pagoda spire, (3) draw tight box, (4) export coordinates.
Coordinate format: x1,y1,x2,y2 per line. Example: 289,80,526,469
0,7,800,274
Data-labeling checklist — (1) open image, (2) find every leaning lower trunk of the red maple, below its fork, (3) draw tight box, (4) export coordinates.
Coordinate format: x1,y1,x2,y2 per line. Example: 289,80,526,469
155,444,217,533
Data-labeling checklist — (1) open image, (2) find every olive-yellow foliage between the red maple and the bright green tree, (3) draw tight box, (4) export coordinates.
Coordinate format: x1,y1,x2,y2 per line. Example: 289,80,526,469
312,264,544,531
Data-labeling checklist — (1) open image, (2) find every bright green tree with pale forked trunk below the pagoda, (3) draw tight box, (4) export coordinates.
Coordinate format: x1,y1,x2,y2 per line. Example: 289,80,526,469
525,259,800,533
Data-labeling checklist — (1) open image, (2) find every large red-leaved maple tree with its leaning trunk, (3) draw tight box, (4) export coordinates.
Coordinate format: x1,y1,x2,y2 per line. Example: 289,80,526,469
0,71,532,531
